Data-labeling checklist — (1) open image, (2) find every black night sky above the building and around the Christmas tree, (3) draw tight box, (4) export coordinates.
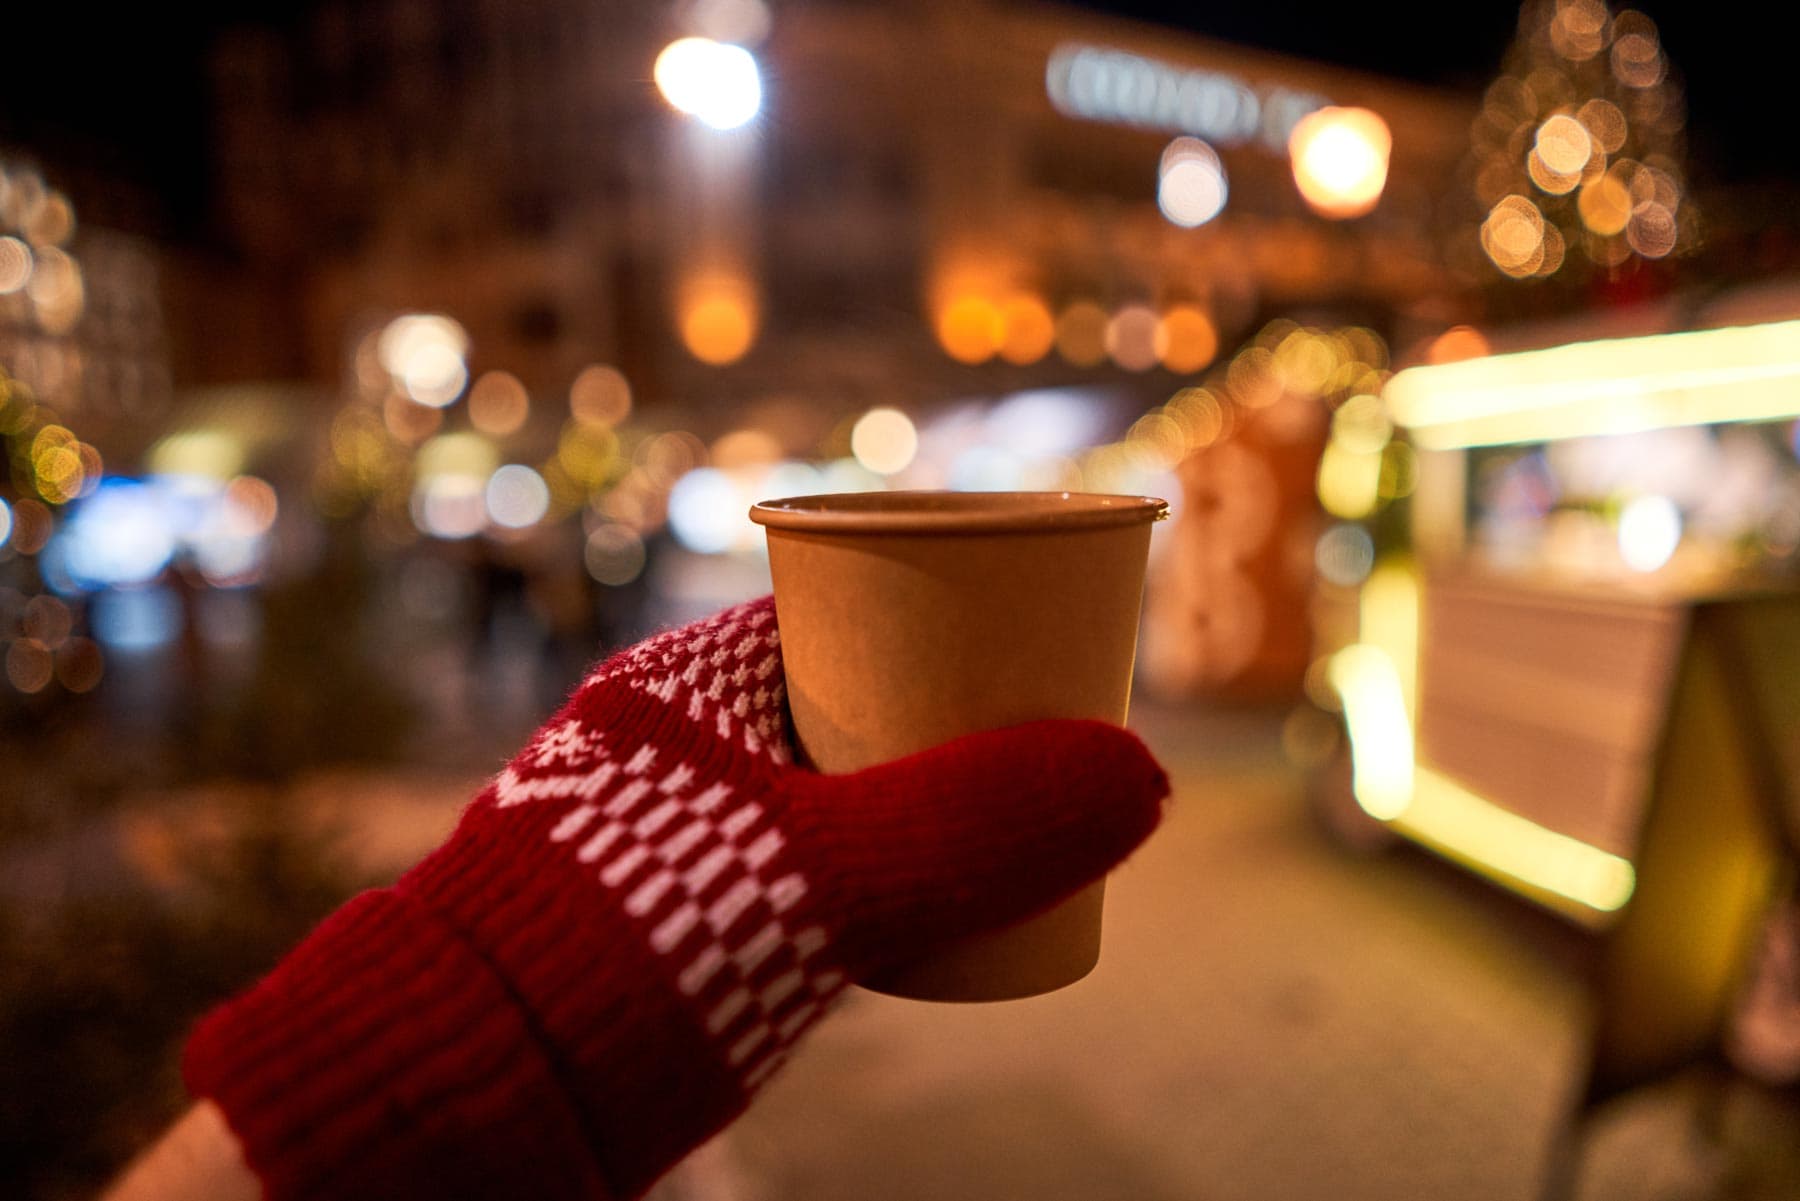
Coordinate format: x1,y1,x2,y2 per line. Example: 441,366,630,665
0,0,1800,238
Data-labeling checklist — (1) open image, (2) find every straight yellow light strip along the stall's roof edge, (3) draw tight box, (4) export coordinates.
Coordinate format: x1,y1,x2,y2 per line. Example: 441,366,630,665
1382,321,1800,450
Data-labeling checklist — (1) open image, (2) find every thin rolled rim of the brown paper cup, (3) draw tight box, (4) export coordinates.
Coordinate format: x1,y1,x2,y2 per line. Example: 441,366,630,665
751,492,1168,535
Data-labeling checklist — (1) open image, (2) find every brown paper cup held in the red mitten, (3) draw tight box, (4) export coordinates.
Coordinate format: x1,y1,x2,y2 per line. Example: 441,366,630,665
751,492,1168,1001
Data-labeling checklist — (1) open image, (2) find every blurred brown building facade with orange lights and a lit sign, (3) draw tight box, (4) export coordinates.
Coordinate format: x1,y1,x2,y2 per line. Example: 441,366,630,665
216,0,1472,423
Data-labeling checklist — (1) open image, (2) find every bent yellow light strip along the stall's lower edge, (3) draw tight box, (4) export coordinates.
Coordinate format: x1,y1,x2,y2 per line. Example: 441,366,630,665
1328,643,1636,917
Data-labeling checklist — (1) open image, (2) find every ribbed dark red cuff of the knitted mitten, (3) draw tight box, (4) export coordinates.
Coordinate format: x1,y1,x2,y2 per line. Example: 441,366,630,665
184,889,607,1201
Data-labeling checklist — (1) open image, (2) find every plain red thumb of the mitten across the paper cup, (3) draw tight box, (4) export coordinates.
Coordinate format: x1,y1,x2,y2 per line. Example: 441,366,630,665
792,720,1168,980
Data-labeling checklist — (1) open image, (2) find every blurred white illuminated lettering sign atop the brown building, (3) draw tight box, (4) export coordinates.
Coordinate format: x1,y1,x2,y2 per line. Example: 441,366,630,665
1044,43,1330,155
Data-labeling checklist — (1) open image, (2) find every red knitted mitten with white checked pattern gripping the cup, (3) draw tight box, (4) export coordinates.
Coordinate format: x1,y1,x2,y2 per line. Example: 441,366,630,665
184,598,1168,1201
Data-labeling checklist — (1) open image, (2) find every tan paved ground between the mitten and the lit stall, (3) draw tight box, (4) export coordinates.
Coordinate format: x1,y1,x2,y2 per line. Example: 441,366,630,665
659,711,1800,1201
